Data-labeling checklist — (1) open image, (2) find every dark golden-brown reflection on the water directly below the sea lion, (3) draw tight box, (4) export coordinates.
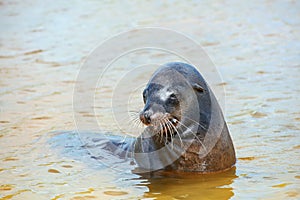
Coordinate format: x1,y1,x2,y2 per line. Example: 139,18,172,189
140,167,238,199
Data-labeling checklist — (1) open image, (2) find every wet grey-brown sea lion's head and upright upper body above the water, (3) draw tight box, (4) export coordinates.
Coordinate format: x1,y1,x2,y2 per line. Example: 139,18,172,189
133,62,236,173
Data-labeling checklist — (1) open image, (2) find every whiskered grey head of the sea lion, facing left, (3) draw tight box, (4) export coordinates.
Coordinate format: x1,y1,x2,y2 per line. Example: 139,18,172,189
140,62,207,140
